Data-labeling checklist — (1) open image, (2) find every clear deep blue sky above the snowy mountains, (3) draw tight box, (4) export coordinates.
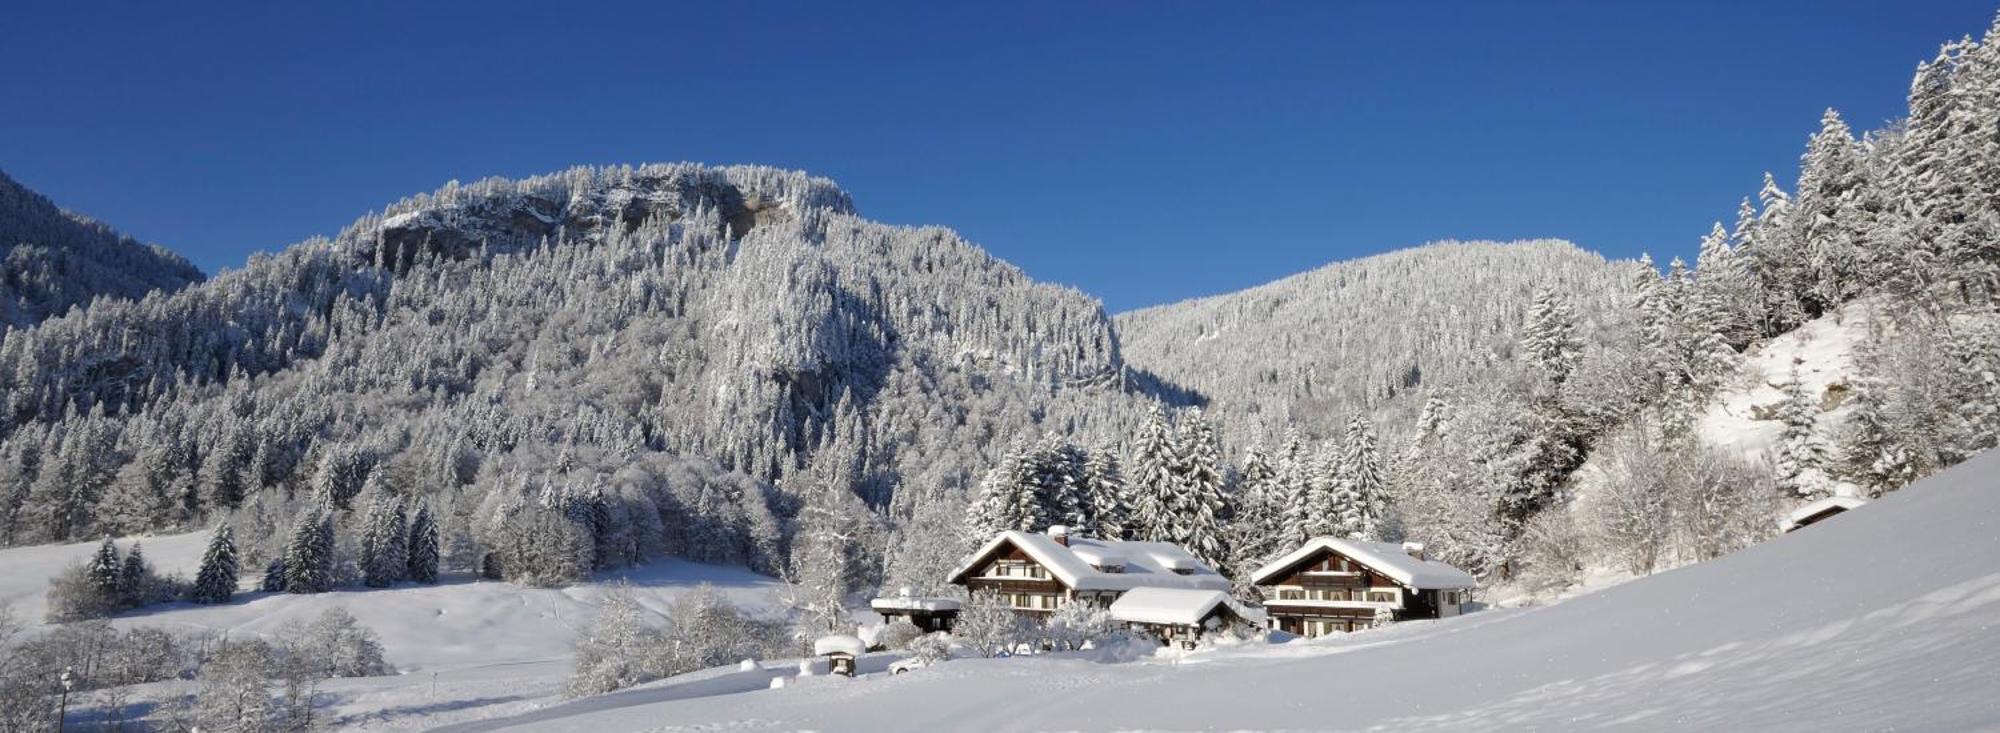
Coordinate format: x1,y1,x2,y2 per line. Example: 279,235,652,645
0,0,1996,310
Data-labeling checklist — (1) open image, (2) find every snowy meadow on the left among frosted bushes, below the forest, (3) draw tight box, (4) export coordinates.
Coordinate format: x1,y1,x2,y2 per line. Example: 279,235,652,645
0,533,778,729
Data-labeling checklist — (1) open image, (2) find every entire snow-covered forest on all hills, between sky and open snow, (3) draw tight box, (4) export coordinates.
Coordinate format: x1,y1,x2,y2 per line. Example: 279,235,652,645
0,10,2000,728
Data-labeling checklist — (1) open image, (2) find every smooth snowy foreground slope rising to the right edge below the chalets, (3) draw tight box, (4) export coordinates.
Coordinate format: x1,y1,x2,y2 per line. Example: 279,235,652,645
454,446,2000,731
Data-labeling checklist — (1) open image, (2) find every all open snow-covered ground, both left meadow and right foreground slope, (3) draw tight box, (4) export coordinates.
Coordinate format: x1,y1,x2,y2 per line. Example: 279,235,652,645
0,453,2000,733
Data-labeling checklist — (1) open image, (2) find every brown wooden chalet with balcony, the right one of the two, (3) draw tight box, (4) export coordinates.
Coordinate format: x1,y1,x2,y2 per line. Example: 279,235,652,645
1250,537,1478,637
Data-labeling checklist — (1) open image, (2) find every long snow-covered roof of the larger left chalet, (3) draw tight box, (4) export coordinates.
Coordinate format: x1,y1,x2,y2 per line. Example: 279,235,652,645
952,531,1230,591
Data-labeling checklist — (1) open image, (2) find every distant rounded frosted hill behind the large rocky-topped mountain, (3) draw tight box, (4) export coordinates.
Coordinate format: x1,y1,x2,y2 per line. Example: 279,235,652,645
1116,240,1626,443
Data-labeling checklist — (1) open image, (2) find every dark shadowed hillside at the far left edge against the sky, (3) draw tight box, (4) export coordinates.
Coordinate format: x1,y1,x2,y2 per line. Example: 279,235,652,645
0,172,202,328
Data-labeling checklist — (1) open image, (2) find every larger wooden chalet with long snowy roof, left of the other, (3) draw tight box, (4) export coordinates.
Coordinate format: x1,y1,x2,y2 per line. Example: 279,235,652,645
950,527,1230,617
